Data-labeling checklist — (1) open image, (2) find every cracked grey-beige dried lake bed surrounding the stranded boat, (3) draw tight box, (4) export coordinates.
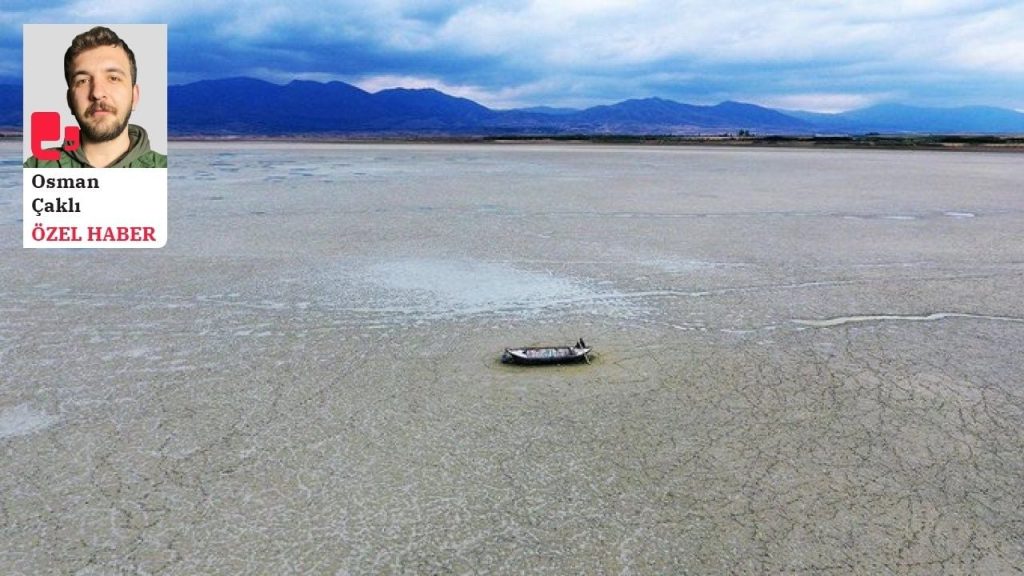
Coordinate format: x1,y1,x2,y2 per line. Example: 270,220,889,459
0,142,1024,574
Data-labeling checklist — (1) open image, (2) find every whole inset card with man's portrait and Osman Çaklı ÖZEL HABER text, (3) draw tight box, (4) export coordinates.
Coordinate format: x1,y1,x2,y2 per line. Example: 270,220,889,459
22,24,167,248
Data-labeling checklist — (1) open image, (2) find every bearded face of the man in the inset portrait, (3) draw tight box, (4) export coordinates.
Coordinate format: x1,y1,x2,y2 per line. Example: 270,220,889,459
68,46,138,142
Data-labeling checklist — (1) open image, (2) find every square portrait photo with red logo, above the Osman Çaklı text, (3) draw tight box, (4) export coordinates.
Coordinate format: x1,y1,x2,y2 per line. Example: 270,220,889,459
24,24,167,168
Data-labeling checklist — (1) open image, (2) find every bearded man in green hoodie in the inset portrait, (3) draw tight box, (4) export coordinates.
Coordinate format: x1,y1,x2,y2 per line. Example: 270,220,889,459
25,26,167,168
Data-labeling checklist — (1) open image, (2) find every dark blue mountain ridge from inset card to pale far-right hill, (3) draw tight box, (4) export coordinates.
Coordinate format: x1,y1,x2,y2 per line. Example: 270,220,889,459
168,78,813,134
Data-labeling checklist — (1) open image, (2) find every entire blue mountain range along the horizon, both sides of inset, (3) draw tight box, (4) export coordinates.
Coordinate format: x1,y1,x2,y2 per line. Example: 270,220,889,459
0,78,1024,136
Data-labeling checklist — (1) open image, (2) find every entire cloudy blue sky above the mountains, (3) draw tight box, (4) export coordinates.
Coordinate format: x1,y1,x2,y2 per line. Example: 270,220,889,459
0,0,1024,112
